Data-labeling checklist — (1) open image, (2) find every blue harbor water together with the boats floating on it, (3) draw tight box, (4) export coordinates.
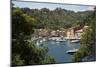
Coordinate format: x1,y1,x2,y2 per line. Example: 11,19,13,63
32,37,80,63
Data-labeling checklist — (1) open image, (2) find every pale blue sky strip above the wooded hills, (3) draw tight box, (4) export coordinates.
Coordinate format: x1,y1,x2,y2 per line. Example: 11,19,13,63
12,1,95,12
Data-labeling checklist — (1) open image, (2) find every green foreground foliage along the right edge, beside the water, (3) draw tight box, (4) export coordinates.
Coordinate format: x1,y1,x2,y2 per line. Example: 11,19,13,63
73,28,95,62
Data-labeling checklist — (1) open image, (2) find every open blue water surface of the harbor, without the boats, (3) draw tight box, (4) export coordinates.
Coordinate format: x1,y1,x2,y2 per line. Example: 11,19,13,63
37,40,80,63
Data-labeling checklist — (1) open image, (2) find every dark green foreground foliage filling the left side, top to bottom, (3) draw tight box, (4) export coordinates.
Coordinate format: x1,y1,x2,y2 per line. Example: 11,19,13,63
12,8,53,66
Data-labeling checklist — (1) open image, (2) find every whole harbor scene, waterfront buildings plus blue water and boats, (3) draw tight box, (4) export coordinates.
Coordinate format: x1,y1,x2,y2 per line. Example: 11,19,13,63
31,25,88,63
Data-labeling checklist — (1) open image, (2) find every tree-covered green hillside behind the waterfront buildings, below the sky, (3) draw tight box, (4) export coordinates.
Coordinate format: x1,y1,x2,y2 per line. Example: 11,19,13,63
21,8,93,30
